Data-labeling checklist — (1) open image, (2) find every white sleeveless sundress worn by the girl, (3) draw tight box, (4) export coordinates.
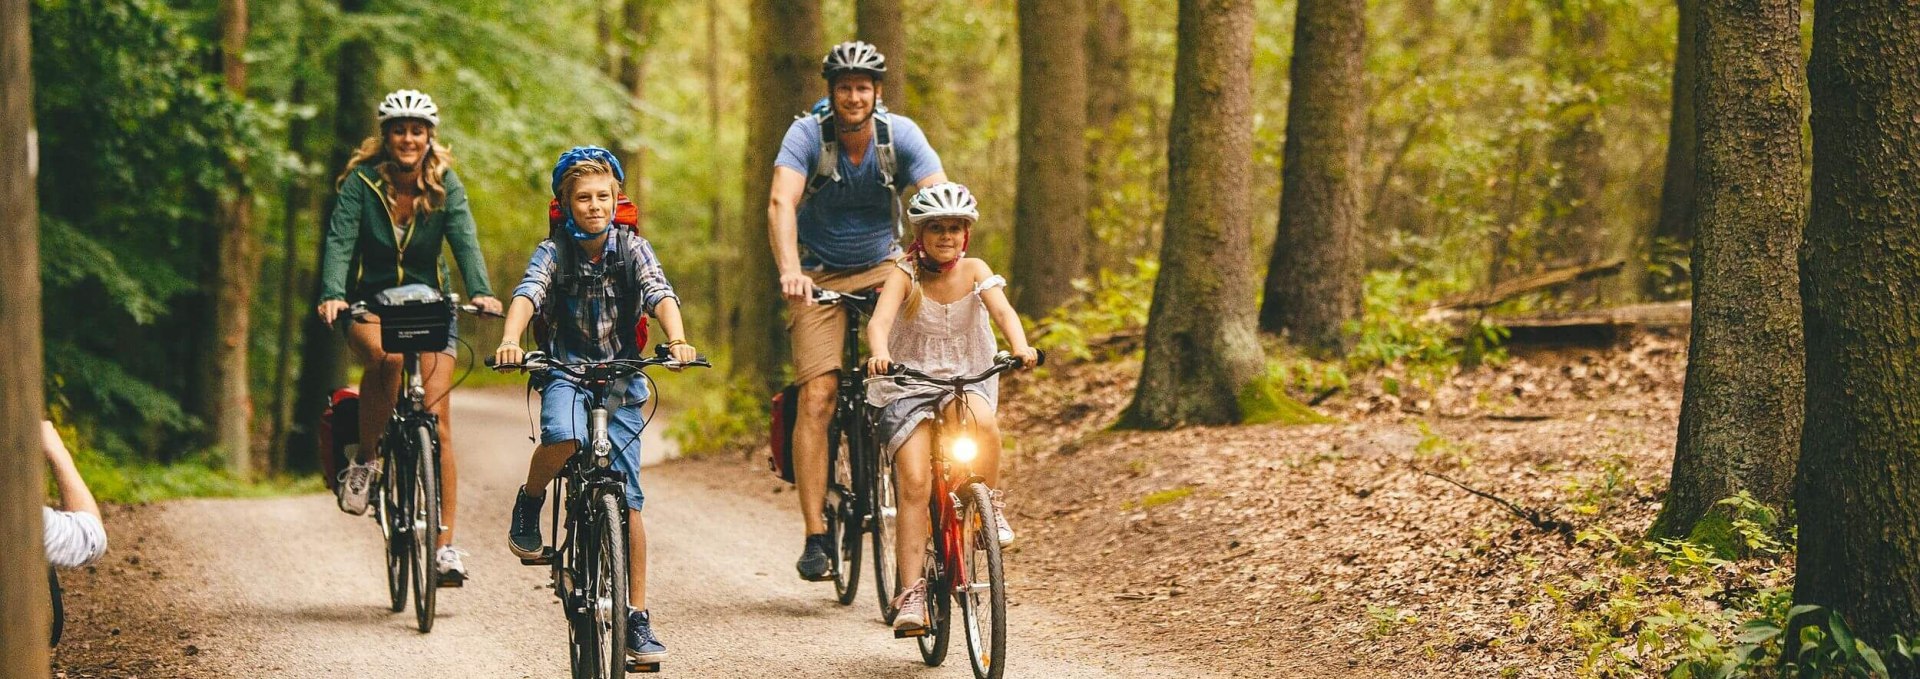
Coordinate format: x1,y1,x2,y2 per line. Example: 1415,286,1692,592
866,263,1006,455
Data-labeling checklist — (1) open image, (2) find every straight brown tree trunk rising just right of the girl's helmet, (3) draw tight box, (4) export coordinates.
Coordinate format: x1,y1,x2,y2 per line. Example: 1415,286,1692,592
1012,0,1087,316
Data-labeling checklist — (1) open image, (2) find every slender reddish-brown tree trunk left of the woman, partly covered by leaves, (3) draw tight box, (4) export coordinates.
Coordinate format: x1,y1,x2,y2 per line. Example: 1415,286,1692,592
202,0,259,478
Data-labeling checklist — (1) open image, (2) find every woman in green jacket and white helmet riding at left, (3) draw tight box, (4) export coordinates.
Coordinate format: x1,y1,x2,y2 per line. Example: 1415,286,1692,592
317,90,499,585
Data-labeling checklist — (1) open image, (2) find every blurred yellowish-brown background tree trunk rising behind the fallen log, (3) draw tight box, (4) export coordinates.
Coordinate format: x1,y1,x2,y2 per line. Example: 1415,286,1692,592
1536,0,1617,299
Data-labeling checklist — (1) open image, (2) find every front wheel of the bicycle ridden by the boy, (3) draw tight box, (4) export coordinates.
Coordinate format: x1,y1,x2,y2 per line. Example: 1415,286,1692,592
566,491,628,679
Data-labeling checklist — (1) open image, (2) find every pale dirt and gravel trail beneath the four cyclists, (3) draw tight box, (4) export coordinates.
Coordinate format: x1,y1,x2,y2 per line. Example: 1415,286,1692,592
61,389,1208,679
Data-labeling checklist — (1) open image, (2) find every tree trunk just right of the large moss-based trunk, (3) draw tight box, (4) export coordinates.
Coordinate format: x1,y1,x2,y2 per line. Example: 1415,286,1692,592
1260,0,1367,353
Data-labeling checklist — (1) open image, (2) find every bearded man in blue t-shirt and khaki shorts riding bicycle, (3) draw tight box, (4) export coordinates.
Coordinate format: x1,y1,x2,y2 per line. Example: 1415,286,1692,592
766,42,947,581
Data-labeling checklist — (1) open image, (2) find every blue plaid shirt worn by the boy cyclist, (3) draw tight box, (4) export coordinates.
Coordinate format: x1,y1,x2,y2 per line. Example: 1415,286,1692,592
513,226,680,405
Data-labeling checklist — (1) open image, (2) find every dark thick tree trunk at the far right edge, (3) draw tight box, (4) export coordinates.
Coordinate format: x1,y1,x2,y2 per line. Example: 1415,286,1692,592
1776,0,1920,648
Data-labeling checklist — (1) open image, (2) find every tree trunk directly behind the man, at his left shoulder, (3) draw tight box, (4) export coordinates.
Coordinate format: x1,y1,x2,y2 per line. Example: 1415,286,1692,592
730,0,824,393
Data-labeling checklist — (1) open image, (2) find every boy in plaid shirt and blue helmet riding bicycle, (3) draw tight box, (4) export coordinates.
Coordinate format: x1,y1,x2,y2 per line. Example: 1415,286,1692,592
493,146,699,664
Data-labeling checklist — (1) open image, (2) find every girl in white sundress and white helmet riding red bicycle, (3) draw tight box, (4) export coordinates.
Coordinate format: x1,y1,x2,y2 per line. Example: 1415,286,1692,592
866,182,1037,629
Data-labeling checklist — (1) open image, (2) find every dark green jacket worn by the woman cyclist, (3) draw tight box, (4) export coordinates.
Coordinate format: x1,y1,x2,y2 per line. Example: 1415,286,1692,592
321,163,493,301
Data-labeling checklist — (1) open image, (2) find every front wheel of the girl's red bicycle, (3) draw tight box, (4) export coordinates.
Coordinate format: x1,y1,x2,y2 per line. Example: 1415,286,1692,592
954,483,1006,679
